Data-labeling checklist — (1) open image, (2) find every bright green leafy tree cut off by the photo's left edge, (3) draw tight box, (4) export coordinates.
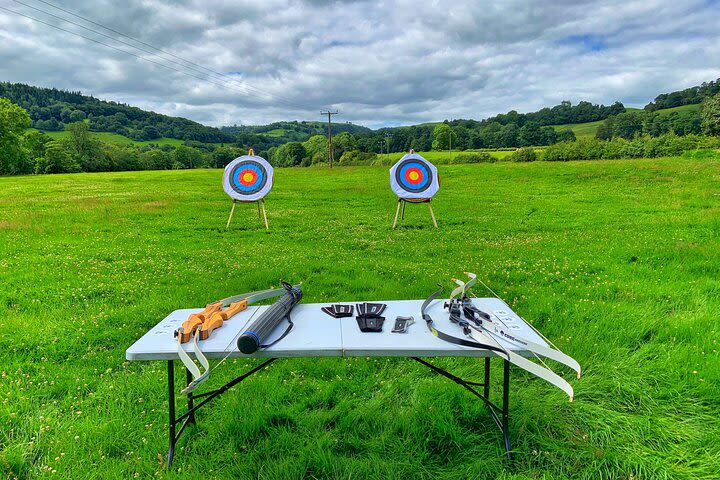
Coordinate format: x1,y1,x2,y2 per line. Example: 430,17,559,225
0,98,30,175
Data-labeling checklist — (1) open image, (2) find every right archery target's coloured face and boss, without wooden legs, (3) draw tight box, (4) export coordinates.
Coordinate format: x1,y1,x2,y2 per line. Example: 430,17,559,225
390,153,440,199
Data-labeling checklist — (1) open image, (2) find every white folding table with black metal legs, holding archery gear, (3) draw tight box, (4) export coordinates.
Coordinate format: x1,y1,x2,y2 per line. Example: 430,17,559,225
125,298,547,468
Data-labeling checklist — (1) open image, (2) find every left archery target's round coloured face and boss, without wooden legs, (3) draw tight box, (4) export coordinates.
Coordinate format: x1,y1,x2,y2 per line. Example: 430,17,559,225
223,155,273,202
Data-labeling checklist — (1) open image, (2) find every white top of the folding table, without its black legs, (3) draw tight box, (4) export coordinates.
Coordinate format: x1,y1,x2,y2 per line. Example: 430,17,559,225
125,298,547,360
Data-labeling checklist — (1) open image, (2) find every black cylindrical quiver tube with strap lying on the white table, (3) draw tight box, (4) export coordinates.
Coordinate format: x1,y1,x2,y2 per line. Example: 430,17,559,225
238,282,302,354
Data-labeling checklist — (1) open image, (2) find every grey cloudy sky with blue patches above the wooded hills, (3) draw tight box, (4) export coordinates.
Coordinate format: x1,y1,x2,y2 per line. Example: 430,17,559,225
0,0,720,127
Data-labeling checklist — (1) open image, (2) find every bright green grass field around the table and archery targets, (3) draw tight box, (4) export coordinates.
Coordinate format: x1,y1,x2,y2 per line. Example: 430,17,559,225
0,158,720,480
